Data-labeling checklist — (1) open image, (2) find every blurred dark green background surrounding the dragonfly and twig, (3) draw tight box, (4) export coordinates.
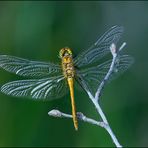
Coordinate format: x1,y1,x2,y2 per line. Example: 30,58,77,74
0,1,148,146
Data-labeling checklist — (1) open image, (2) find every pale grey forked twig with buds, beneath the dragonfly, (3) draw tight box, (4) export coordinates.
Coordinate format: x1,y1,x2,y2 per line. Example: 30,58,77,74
48,42,126,147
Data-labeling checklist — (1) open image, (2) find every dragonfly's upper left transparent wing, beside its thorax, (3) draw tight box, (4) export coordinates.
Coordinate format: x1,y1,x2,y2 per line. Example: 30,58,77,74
0,55,61,77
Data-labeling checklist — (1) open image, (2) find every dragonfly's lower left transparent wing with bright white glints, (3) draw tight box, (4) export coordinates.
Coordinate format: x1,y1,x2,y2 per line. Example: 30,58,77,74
1,76,68,100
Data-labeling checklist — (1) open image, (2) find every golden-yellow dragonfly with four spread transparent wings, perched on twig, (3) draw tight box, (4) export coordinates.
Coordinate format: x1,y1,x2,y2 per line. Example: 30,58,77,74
0,26,133,130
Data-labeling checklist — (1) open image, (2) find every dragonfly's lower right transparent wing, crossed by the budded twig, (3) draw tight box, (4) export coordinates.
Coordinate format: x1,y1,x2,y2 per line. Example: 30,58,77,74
76,55,133,95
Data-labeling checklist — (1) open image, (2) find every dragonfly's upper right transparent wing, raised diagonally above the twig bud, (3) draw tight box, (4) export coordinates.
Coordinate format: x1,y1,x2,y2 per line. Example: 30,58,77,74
74,26,123,67
